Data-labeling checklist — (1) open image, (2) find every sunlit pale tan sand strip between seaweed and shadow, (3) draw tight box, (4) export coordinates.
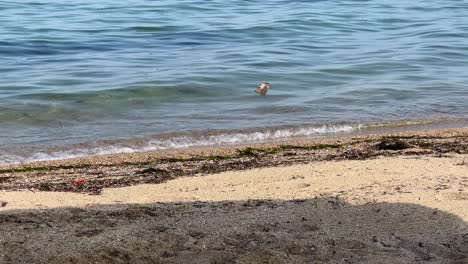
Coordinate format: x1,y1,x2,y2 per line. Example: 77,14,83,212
0,155,468,214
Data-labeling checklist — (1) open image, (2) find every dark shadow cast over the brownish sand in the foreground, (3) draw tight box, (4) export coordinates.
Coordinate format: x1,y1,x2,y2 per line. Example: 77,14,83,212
0,197,468,264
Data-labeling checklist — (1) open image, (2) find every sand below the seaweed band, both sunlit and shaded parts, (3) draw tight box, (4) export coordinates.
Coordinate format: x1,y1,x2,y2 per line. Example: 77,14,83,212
0,128,468,264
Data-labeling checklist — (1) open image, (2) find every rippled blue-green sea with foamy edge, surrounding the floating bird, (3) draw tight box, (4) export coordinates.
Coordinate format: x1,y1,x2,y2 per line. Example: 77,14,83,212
0,0,468,164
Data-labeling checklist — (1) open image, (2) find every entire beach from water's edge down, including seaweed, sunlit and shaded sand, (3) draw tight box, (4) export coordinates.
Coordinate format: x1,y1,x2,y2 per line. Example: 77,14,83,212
0,129,468,264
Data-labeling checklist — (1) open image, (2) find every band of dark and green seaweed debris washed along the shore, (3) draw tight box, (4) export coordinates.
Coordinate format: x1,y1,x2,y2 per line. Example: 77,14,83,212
0,128,468,194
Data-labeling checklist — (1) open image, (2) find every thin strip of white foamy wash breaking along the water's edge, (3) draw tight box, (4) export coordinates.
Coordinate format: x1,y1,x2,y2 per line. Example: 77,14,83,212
0,118,468,167
